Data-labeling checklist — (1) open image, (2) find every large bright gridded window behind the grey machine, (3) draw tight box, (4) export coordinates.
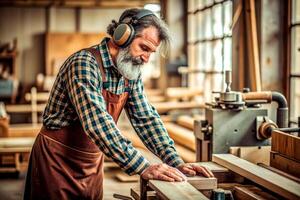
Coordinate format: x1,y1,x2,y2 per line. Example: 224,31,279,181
188,0,232,102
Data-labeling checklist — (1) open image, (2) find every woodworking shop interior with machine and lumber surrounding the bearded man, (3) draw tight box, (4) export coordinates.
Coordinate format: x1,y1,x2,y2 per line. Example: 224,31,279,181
0,0,300,200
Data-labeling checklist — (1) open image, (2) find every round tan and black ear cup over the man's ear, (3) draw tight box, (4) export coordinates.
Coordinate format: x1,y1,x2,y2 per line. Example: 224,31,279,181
113,24,134,47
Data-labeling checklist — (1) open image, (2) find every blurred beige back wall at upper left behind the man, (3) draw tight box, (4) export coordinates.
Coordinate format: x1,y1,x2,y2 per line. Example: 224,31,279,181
0,7,123,88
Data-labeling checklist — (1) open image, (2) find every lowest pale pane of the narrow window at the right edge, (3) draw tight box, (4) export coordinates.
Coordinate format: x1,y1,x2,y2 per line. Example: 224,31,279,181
290,78,300,120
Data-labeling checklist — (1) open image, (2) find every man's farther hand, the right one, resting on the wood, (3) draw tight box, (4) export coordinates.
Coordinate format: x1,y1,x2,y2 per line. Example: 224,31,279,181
177,163,214,177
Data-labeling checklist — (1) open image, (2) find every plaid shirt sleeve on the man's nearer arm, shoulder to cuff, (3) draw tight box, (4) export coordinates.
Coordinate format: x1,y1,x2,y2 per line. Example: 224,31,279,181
65,53,149,174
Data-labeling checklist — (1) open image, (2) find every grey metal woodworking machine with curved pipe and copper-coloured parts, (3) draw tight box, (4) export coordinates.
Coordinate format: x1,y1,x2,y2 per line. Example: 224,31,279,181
194,71,299,161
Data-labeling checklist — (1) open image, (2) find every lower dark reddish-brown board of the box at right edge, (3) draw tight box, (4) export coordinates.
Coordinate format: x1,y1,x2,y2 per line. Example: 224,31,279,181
270,151,300,178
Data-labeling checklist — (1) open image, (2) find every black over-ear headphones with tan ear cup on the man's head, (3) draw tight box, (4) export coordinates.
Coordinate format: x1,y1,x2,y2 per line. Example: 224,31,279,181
112,9,155,48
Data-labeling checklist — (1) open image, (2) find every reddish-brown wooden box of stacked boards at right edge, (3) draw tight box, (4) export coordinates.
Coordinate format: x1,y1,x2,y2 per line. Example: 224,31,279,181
270,131,300,178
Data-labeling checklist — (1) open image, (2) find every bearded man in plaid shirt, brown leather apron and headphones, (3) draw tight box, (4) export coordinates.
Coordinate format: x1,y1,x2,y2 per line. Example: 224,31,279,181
24,9,213,199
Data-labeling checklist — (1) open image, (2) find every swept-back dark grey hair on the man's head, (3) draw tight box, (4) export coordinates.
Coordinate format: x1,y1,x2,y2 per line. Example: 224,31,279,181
107,8,171,56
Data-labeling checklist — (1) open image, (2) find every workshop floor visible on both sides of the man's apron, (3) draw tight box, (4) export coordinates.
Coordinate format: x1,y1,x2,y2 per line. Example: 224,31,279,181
0,168,139,200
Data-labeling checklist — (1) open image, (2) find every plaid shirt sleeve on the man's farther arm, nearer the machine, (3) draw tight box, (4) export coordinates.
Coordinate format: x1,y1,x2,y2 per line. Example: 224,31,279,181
125,79,184,167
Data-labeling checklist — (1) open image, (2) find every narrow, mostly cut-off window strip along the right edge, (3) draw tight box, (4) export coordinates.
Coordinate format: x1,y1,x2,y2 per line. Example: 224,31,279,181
289,0,300,121
